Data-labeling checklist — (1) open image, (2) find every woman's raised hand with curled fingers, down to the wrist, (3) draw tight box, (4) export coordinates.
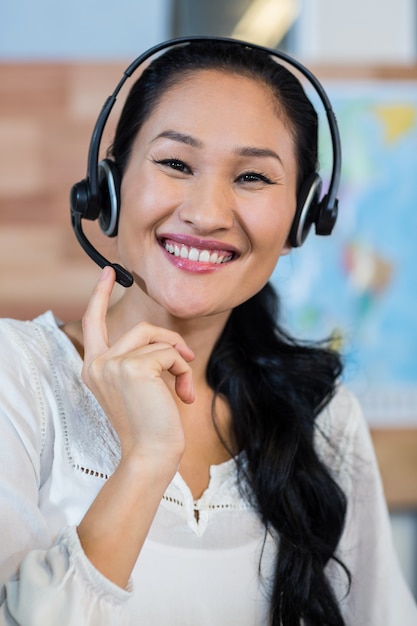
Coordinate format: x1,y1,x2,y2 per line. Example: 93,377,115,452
82,267,194,462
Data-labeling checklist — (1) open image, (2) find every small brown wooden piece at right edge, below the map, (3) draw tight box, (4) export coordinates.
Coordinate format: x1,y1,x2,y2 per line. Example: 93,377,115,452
371,428,417,510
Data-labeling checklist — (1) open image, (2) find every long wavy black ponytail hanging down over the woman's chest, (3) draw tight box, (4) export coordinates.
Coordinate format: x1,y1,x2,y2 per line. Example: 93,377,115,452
208,284,350,626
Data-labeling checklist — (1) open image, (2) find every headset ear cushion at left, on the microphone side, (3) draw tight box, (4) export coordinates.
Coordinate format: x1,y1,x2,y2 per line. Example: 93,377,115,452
98,159,121,237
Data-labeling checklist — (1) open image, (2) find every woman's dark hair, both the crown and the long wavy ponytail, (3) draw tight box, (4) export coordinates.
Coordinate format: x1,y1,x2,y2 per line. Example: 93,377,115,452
109,42,350,626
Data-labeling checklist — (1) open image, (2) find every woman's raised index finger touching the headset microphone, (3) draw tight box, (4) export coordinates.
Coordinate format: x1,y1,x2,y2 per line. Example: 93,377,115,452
82,265,116,361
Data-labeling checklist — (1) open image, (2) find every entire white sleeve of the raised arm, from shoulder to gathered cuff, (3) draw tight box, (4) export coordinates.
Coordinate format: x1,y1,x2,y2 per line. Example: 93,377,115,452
0,322,131,626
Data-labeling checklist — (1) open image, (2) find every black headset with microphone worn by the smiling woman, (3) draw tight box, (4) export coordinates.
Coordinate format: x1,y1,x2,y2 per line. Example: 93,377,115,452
70,36,342,287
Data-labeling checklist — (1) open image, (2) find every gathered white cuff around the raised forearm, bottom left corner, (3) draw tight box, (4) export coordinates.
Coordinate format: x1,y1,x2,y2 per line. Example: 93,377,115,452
0,527,130,626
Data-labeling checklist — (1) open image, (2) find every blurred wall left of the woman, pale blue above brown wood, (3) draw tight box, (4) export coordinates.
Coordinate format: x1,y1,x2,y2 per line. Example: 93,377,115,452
0,0,171,319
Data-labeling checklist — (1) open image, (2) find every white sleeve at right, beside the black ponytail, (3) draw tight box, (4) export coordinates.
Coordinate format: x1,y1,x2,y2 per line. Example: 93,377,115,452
324,394,417,626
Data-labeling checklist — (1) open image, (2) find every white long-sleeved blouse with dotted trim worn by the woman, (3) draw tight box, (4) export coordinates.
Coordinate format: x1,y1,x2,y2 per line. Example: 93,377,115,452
0,312,417,626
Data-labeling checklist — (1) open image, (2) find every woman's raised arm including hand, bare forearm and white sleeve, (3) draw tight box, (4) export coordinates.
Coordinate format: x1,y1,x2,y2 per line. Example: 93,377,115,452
0,272,192,626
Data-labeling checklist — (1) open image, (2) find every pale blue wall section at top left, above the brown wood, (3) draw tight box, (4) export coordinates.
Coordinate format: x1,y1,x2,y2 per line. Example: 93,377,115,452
0,0,171,61
